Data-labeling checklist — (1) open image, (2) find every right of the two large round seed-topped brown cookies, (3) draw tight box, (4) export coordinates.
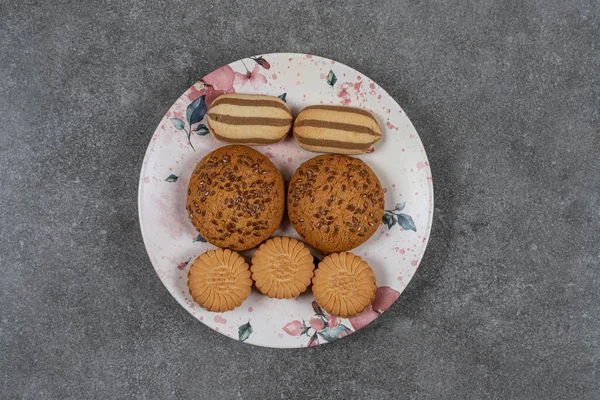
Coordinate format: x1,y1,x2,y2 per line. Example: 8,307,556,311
287,154,384,253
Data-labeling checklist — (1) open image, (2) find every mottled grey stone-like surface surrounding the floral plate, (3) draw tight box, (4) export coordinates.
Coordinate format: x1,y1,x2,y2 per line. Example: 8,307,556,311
0,0,600,399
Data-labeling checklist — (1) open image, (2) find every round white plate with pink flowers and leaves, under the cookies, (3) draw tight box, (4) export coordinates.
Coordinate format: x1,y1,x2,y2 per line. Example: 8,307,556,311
138,53,433,348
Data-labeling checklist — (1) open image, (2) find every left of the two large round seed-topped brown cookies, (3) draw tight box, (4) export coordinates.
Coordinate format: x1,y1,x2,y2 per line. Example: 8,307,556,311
186,146,285,251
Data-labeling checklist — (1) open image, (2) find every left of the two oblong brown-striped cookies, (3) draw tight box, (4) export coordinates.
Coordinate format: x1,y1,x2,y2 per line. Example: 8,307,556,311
208,93,293,145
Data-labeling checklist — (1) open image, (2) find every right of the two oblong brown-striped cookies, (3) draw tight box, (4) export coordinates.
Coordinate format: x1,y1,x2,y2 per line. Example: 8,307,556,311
294,105,382,154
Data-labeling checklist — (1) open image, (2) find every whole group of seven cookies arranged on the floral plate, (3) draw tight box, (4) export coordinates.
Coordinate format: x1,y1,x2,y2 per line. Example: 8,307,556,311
186,94,384,318
